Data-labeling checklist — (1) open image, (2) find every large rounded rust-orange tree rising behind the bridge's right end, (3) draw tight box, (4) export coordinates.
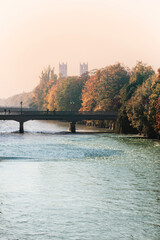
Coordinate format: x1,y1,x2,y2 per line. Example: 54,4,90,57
82,63,129,111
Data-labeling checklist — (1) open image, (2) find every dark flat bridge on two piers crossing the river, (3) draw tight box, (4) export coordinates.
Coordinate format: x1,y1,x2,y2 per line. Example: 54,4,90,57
0,108,118,133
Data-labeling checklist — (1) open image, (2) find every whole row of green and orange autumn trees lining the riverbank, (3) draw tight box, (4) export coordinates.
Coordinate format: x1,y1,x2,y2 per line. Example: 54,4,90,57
30,62,160,138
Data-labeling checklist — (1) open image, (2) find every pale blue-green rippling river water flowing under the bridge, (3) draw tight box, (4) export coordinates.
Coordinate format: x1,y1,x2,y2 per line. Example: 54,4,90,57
0,121,160,240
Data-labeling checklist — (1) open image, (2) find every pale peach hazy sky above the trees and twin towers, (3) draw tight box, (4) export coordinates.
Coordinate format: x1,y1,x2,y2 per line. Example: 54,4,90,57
0,0,160,98
